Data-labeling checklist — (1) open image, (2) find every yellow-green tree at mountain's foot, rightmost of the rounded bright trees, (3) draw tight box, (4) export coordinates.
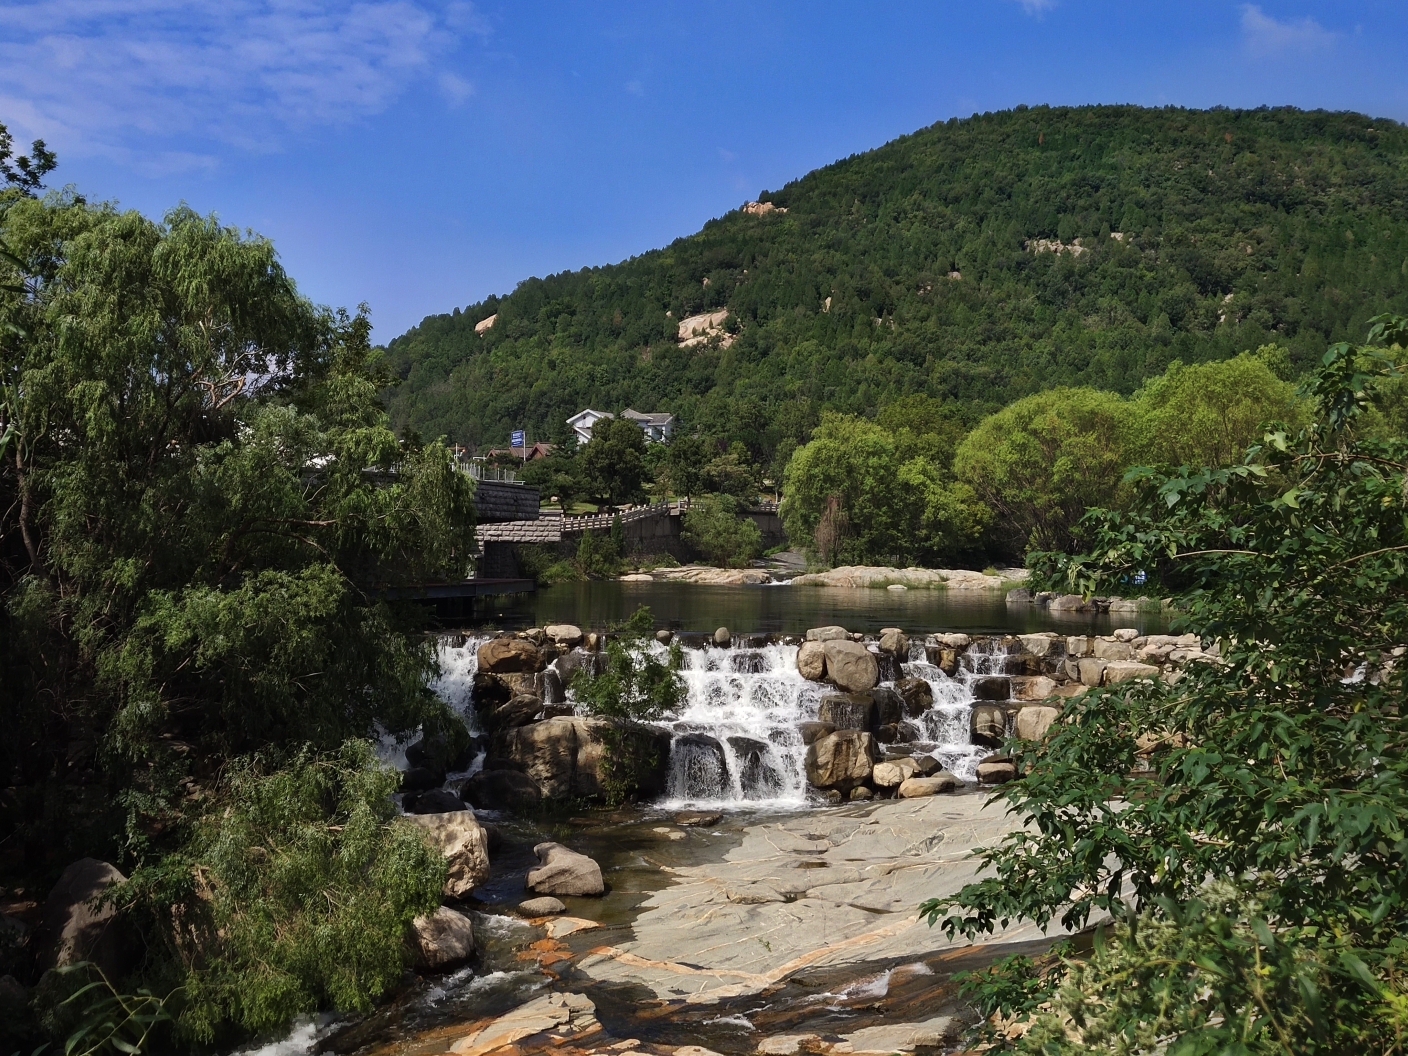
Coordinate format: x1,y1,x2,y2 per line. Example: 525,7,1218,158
1133,352,1309,466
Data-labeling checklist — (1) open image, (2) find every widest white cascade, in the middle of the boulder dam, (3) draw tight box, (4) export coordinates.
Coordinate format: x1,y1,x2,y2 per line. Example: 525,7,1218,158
666,645,824,805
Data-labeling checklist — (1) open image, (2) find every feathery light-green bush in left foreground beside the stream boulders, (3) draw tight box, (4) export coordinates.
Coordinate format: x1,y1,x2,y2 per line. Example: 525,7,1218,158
111,741,445,1042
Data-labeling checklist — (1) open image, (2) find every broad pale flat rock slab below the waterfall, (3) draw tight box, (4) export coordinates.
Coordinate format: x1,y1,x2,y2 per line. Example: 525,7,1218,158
579,796,1055,1002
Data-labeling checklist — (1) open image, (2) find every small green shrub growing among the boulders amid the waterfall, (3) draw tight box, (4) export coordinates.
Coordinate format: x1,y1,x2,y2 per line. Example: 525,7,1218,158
572,605,686,805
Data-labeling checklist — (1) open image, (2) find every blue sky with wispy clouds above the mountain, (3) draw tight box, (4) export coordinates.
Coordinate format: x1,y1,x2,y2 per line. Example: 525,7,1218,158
0,0,1408,341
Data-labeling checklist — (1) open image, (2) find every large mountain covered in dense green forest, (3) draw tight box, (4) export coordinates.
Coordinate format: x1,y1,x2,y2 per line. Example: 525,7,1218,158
389,107,1408,459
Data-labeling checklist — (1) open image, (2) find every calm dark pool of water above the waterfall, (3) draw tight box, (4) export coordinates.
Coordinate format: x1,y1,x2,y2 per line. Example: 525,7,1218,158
459,580,1170,634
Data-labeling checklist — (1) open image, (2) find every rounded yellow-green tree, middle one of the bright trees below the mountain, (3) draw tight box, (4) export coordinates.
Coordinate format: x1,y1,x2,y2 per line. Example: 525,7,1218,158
953,389,1139,552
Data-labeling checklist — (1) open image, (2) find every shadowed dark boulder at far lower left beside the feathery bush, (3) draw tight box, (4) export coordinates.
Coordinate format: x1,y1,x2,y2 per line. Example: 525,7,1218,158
31,857,134,977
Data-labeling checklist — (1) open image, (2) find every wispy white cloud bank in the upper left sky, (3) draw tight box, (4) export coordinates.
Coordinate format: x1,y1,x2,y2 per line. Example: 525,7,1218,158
0,0,489,165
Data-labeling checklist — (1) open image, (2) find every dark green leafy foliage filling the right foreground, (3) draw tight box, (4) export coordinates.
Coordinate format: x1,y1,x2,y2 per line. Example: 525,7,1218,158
924,325,1408,1053
